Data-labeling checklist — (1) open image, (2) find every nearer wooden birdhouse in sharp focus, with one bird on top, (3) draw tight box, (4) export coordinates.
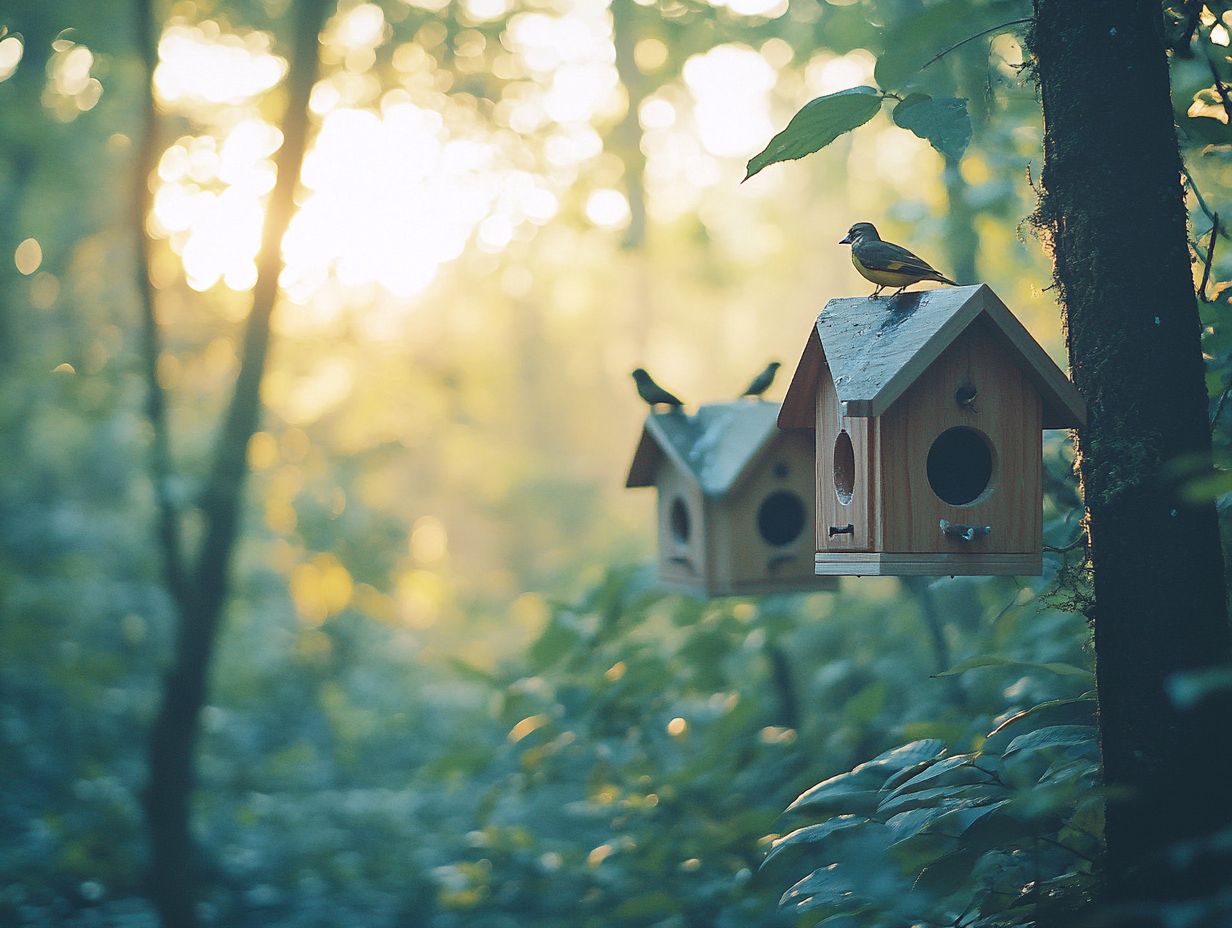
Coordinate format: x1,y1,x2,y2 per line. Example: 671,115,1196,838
779,286,1085,576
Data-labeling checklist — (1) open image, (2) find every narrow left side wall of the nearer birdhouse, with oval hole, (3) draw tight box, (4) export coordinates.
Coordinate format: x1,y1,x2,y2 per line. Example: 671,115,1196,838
813,364,883,551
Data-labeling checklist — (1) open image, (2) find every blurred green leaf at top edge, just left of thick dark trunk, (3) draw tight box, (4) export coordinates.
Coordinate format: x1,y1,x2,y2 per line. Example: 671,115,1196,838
873,0,1031,90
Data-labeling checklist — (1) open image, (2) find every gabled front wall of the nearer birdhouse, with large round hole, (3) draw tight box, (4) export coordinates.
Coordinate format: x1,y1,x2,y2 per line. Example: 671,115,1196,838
877,319,1044,553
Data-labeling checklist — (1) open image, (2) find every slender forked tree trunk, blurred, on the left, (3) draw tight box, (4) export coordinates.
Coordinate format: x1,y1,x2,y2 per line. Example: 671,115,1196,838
137,0,333,928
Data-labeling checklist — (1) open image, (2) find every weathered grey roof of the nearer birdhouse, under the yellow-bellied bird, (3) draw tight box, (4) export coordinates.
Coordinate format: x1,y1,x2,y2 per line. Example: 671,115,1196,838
779,283,1087,429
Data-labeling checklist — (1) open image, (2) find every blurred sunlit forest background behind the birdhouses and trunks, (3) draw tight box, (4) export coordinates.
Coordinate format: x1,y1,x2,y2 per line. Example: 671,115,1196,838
0,0,1232,928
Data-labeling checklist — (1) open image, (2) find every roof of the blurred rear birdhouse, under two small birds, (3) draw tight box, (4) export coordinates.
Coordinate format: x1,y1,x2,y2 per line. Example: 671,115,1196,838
625,401,779,497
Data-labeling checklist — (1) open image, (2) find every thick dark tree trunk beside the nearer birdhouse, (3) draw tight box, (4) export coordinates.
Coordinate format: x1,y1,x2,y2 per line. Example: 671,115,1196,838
1031,0,1232,911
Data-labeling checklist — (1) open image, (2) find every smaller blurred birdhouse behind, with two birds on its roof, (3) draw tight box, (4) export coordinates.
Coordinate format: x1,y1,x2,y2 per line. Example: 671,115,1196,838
625,401,837,596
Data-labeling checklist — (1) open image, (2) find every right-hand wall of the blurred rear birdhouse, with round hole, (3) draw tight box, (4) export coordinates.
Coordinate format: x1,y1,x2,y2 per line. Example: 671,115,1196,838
710,433,819,589
